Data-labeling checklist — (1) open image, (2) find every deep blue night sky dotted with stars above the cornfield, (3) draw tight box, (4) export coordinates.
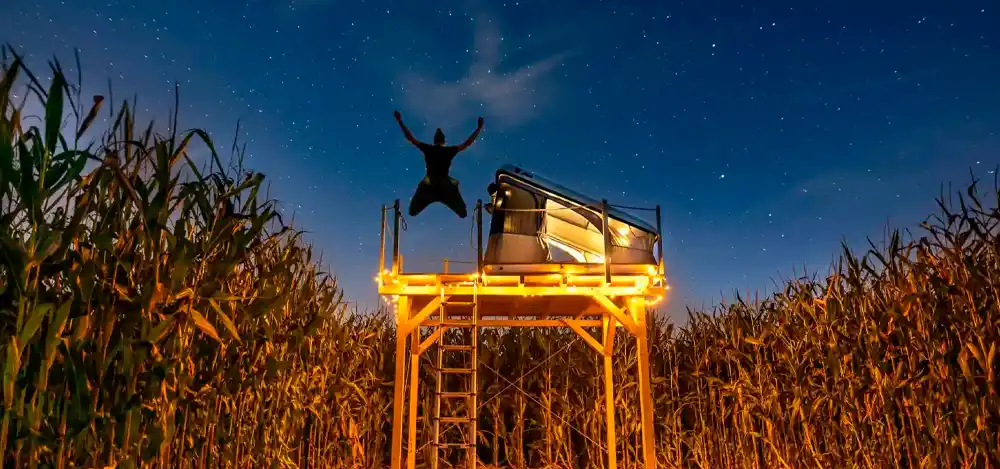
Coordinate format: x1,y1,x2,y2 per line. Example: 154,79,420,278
0,0,1000,321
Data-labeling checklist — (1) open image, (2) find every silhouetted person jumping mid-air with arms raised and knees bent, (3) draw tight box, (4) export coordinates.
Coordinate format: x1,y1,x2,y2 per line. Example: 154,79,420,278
393,111,483,218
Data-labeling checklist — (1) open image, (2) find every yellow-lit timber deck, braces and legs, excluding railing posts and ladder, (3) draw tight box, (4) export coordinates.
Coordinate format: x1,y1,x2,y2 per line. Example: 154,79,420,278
376,266,668,469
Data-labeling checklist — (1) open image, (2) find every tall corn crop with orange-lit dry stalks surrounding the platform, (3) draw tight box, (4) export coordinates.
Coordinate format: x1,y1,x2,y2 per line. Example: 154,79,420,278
0,49,1000,468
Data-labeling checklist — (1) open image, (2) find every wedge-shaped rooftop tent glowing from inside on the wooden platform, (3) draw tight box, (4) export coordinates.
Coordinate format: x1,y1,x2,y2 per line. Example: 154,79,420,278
484,165,657,264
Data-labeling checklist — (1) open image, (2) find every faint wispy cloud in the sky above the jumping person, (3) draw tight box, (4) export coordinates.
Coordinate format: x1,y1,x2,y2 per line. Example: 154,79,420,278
402,14,569,133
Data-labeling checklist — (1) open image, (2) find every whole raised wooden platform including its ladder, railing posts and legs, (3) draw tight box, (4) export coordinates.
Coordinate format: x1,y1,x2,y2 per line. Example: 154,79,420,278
376,165,668,469
